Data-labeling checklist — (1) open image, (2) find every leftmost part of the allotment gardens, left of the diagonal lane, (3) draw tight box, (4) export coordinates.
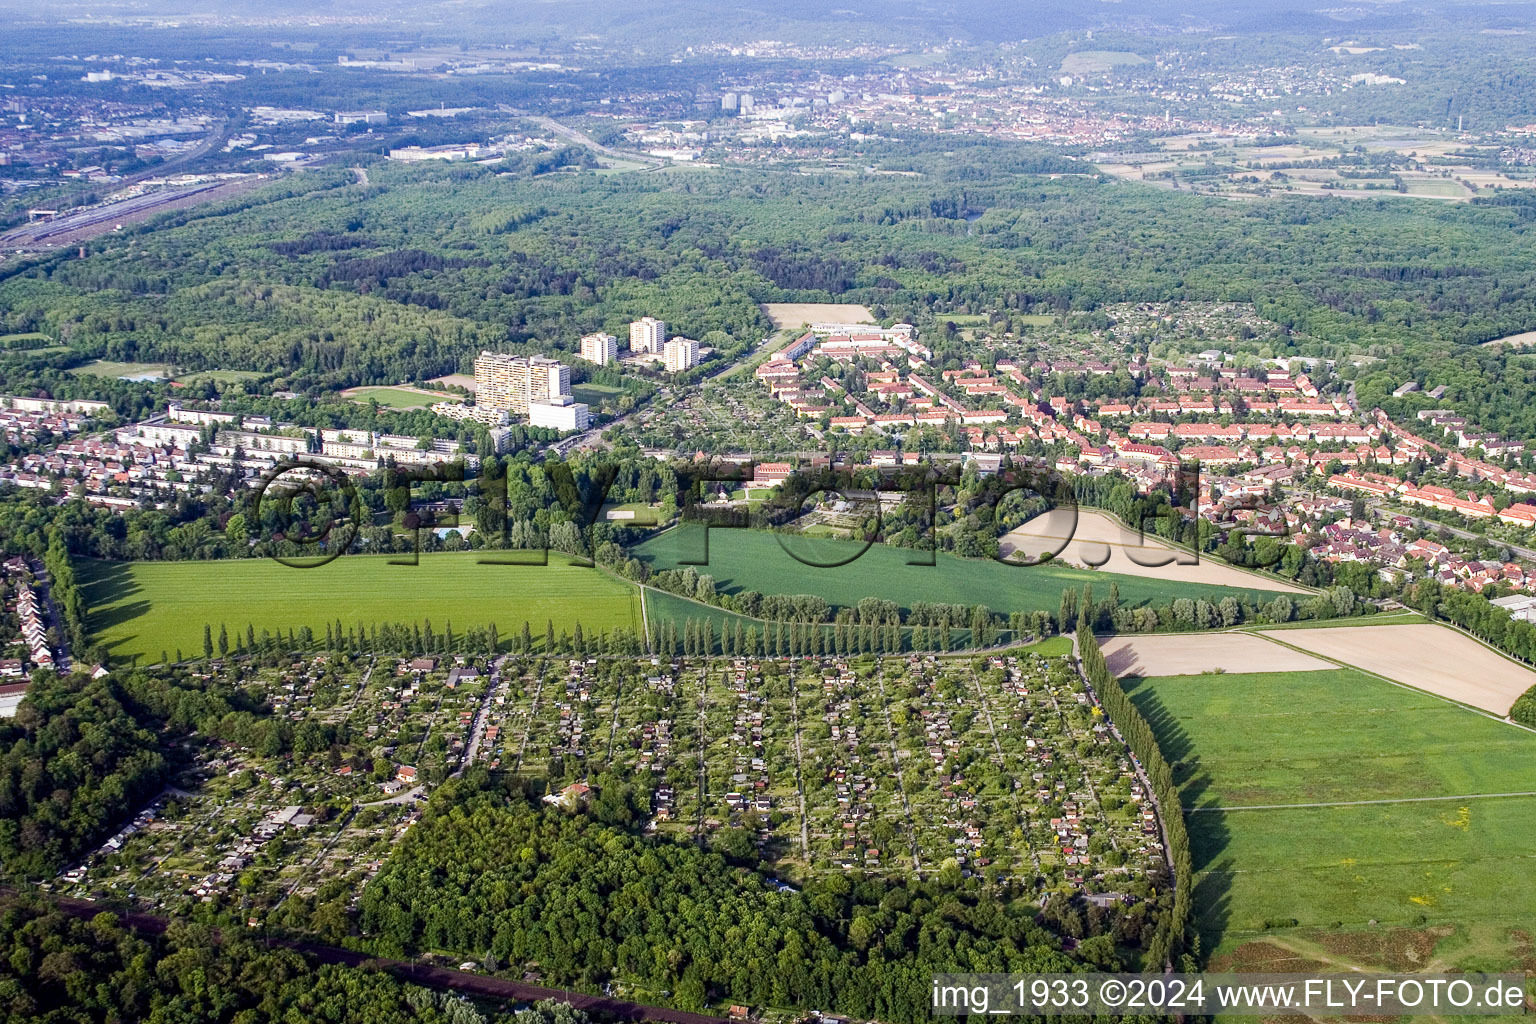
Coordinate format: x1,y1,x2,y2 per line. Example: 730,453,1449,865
58,656,492,923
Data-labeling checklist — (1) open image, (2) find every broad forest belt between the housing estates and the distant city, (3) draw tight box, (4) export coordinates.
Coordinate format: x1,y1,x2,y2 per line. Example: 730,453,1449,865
0,158,1536,423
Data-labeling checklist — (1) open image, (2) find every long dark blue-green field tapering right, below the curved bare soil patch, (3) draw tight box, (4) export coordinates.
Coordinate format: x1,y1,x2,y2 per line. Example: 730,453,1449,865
633,525,1275,613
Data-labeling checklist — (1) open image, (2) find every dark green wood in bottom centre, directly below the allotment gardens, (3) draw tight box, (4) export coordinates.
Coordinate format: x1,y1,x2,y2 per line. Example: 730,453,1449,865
361,772,1167,1021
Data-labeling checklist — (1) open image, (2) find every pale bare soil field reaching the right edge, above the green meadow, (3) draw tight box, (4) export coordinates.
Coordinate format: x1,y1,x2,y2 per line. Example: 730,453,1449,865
1259,622,1536,715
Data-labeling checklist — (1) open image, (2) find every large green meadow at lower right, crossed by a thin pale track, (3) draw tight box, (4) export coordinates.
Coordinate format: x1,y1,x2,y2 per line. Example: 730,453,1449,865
1126,669,1536,966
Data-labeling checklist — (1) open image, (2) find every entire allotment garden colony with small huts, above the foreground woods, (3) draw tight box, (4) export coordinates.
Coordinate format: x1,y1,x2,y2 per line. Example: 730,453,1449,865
58,657,1161,929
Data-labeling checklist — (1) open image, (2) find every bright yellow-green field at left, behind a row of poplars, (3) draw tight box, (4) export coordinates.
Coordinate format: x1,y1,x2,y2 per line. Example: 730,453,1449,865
77,551,641,662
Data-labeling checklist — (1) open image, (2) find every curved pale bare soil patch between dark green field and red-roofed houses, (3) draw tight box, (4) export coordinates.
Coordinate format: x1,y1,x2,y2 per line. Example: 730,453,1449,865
998,508,1309,594
